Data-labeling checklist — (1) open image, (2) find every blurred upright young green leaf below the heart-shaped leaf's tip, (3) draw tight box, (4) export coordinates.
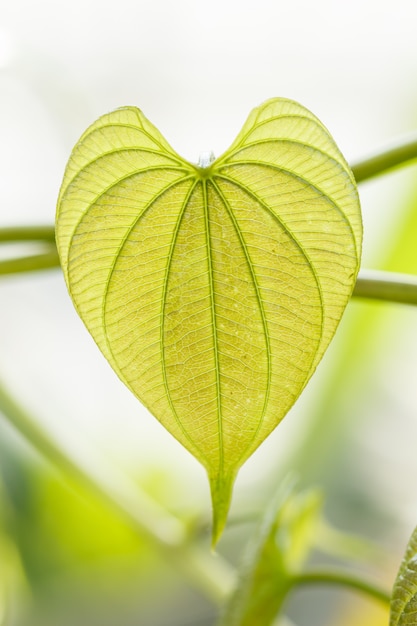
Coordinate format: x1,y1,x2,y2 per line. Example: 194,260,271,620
220,485,322,626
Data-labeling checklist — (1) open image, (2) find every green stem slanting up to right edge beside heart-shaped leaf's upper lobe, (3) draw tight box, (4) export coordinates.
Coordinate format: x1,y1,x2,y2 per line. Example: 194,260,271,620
352,137,417,183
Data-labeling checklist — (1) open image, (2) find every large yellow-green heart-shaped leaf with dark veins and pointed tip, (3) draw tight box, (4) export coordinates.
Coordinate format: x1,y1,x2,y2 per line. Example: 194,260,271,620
57,98,362,539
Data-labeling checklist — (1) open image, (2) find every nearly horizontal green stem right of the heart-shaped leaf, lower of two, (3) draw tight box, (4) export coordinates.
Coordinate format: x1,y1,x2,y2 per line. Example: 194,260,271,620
353,270,417,305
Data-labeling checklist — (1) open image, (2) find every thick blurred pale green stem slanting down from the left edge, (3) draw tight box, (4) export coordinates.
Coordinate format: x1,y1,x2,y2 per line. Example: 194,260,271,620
0,378,235,604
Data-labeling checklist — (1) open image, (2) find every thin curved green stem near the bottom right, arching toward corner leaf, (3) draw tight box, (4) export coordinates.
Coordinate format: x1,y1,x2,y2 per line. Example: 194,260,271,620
291,570,391,607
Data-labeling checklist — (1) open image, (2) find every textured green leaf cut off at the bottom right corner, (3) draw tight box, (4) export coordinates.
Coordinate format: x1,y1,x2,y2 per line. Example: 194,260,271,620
389,528,417,626
